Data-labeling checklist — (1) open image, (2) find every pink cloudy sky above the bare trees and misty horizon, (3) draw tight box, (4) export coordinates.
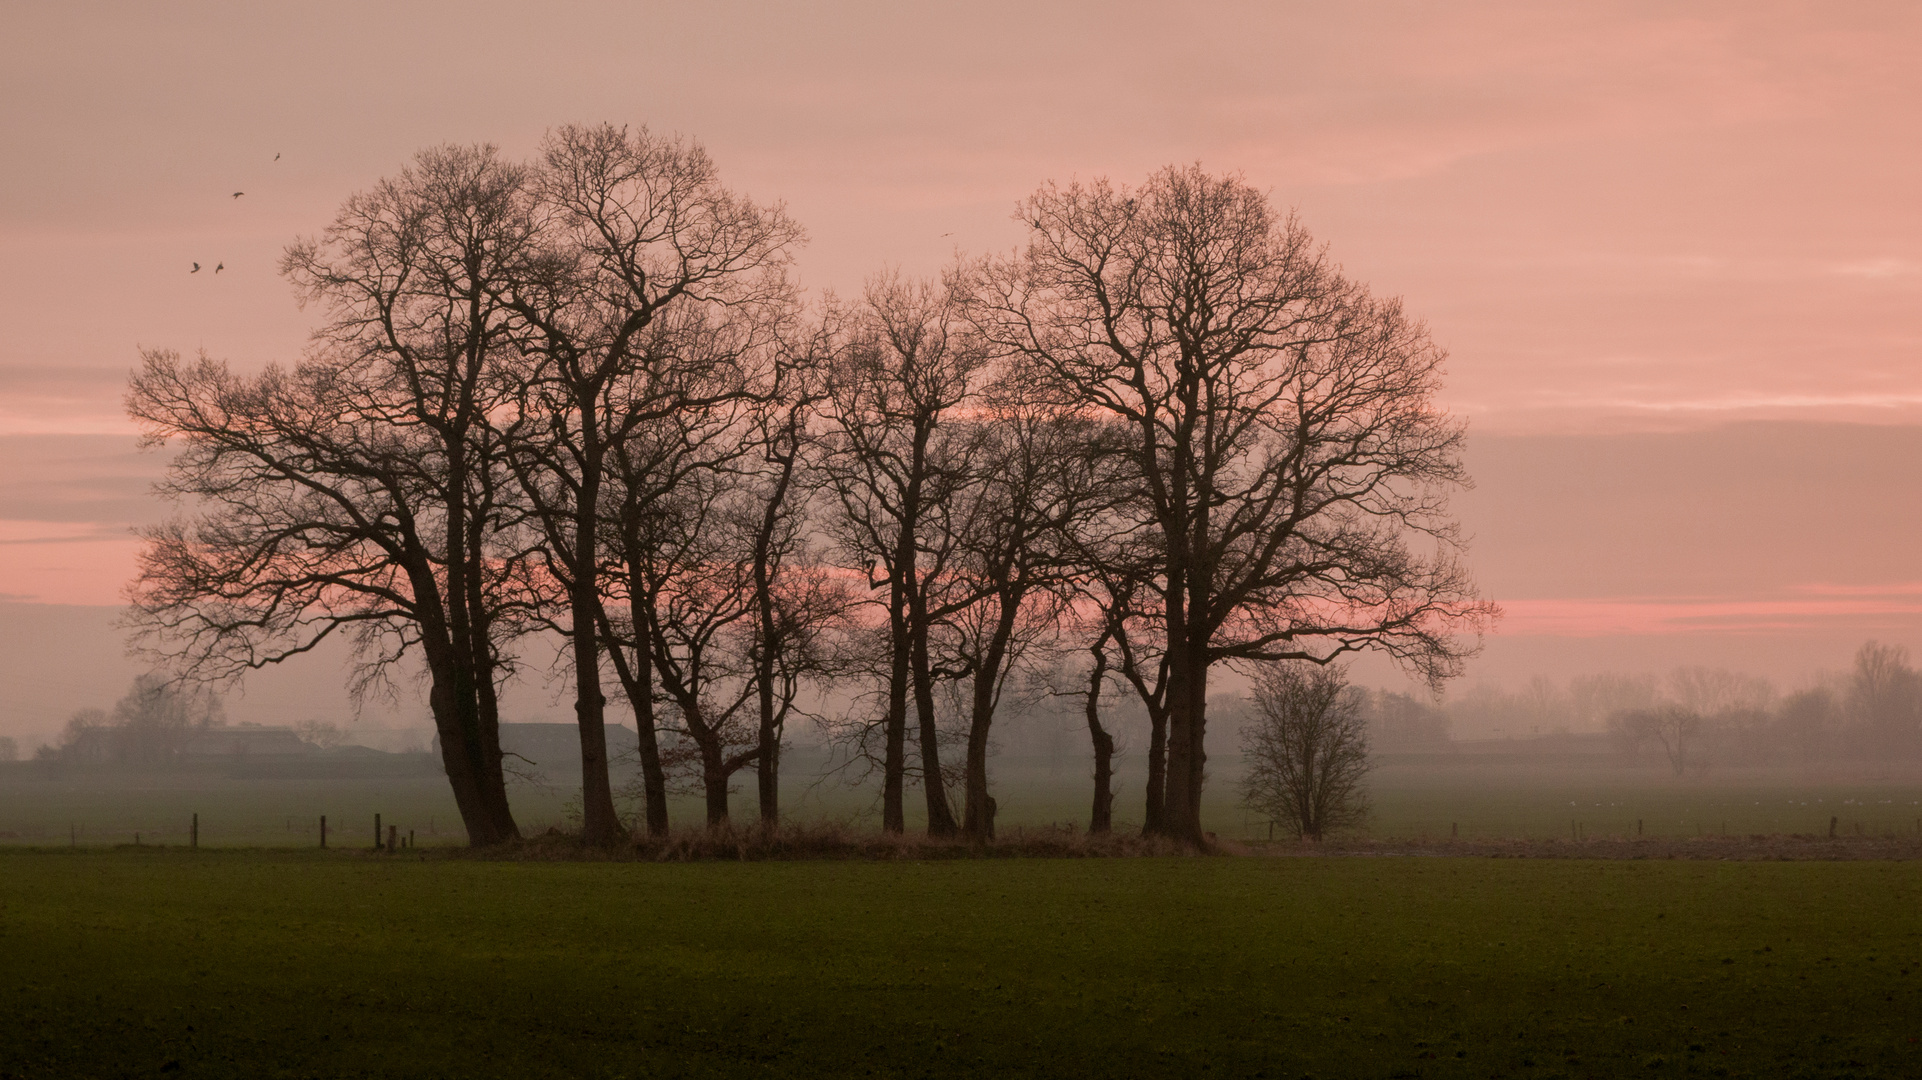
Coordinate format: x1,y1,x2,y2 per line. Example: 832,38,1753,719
0,2,1922,724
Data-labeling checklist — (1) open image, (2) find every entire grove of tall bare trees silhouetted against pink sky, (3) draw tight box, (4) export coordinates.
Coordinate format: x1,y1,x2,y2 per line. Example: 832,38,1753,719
127,125,1493,846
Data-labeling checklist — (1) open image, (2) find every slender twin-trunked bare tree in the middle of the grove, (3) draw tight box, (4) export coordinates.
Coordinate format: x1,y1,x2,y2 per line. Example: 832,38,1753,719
823,277,984,836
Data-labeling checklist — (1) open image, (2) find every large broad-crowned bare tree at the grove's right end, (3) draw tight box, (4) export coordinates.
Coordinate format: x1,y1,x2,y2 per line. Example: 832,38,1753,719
965,167,1493,846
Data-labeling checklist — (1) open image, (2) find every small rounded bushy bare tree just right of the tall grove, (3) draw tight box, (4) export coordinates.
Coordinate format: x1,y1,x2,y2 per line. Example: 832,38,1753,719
1242,661,1368,840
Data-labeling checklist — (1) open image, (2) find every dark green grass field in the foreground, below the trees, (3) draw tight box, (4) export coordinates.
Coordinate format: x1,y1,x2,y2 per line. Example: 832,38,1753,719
0,849,1922,1078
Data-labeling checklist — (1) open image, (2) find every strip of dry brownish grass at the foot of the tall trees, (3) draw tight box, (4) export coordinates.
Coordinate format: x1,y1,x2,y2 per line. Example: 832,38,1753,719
455,822,1190,863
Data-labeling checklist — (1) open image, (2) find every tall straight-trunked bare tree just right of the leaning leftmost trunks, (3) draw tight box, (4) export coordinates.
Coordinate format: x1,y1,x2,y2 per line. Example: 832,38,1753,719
502,125,801,844
